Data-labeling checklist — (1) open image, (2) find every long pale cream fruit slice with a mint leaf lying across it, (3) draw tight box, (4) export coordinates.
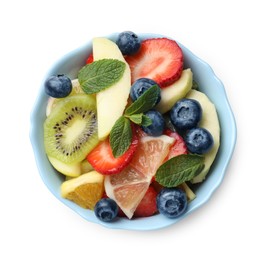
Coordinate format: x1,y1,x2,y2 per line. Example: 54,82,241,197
93,38,131,140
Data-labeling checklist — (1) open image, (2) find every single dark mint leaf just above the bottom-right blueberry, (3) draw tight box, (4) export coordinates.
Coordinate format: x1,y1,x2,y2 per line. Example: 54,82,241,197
155,154,204,187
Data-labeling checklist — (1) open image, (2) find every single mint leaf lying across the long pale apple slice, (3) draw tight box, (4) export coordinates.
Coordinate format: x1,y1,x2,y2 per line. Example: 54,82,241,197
78,59,126,94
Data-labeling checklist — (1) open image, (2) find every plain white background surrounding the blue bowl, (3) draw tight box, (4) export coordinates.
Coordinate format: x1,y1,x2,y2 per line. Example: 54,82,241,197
0,0,267,260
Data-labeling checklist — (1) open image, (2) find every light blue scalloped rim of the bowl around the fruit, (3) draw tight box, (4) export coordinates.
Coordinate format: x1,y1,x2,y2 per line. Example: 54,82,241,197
30,33,237,231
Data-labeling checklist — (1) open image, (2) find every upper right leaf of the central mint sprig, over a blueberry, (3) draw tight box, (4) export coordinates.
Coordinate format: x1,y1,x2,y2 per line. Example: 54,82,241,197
125,85,160,116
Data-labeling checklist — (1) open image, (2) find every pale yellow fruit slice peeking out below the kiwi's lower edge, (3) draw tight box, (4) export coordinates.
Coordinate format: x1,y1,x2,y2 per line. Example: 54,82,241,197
48,156,81,177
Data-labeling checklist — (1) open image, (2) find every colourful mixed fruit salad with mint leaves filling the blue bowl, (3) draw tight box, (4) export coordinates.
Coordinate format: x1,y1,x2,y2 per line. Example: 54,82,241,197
44,31,220,222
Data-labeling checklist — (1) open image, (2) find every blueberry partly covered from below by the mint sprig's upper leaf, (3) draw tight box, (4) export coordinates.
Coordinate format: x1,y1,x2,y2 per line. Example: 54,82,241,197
130,78,161,104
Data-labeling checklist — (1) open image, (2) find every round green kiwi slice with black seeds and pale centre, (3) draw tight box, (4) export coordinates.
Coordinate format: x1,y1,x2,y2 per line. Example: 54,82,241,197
44,94,98,164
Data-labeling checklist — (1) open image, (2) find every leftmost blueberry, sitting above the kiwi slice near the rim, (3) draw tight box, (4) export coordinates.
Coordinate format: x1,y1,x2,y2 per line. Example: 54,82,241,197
45,74,72,98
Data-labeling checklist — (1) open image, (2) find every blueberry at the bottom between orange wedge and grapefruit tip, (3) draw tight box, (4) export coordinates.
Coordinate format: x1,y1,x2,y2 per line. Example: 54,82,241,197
94,198,119,222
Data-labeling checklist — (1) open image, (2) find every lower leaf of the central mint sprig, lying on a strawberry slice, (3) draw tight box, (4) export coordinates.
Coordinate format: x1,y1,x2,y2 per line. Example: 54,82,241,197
109,116,133,158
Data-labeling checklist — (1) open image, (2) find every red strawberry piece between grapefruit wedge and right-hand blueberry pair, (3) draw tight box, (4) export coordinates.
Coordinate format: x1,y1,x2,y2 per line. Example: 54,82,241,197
164,129,188,161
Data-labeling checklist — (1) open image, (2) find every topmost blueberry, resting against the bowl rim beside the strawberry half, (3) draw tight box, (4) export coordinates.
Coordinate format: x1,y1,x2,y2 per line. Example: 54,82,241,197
116,31,141,55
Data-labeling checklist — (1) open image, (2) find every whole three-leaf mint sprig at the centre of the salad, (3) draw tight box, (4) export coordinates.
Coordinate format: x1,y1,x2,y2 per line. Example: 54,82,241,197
109,85,160,158
